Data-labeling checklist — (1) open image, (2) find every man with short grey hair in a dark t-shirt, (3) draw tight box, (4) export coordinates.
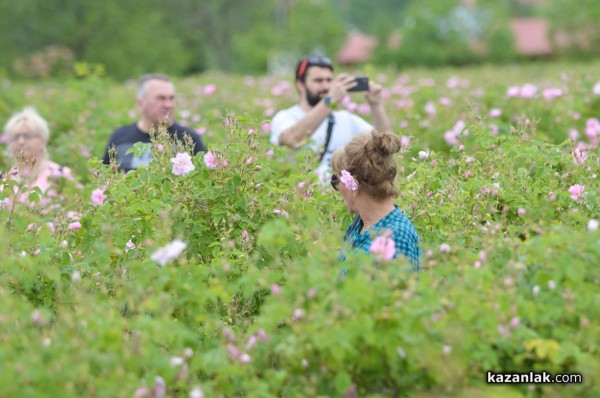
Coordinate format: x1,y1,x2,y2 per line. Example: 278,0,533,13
103,73,206,172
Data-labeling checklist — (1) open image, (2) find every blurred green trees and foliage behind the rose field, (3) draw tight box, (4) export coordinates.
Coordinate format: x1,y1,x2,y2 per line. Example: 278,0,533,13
0,0,600,79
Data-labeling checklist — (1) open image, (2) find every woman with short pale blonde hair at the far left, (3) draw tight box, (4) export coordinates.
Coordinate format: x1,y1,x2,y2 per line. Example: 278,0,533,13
4,107,72,202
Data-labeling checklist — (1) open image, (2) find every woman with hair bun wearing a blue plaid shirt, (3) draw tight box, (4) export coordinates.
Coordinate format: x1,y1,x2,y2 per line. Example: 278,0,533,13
331,131,421,270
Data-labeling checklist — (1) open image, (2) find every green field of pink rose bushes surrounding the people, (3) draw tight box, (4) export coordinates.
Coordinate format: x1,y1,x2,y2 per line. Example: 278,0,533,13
0,62,600,398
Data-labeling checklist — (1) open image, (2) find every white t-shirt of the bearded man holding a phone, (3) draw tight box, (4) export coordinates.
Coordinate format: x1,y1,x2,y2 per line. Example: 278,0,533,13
271,105,373,169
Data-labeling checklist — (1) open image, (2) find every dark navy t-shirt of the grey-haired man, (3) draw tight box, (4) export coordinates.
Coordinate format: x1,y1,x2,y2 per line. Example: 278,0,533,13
103,123,206,172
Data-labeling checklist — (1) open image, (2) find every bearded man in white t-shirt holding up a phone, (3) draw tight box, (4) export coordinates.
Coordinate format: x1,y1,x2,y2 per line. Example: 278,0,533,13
271,57,391,177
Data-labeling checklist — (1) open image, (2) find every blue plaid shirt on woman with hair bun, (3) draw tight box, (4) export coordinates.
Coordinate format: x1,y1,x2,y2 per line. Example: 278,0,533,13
342,206,421,270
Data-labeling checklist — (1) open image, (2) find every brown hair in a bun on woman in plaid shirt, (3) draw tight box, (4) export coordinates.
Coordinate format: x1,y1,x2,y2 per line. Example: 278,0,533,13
331,130,401,199
